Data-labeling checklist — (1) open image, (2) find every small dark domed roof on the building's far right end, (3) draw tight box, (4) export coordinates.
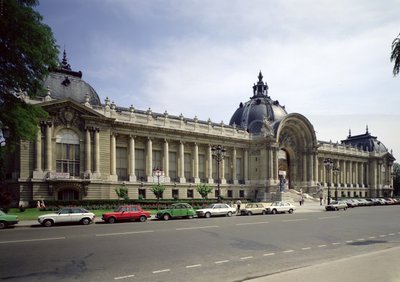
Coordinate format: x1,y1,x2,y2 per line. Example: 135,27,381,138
342,127,388,153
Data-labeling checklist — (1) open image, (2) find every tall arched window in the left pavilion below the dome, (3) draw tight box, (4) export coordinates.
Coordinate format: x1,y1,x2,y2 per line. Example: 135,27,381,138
56,129,80,176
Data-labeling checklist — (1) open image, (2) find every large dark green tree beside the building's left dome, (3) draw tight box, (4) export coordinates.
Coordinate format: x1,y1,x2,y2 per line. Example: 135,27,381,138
0,0,58,151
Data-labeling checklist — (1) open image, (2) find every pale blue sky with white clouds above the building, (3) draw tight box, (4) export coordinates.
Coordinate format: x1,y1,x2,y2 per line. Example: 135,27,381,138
36,0,400,159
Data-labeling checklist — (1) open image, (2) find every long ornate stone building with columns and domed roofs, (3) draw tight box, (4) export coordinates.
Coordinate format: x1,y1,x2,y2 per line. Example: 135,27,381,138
3,53,395,204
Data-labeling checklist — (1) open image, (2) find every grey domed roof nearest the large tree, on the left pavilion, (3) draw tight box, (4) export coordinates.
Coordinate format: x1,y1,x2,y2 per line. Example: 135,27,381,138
44,51,101,105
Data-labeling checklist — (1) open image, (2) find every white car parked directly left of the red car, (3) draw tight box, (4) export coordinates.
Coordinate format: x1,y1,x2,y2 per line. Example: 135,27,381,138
38,207,95,227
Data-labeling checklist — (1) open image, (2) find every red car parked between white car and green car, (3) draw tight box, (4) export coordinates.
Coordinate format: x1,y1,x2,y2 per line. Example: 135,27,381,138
102,205,150,223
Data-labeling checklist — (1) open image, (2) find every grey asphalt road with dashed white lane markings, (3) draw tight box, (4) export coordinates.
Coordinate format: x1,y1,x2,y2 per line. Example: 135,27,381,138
0,206,400,281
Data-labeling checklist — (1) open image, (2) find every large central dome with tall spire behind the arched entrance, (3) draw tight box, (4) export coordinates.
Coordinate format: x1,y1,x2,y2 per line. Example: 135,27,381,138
229,71,287,133
